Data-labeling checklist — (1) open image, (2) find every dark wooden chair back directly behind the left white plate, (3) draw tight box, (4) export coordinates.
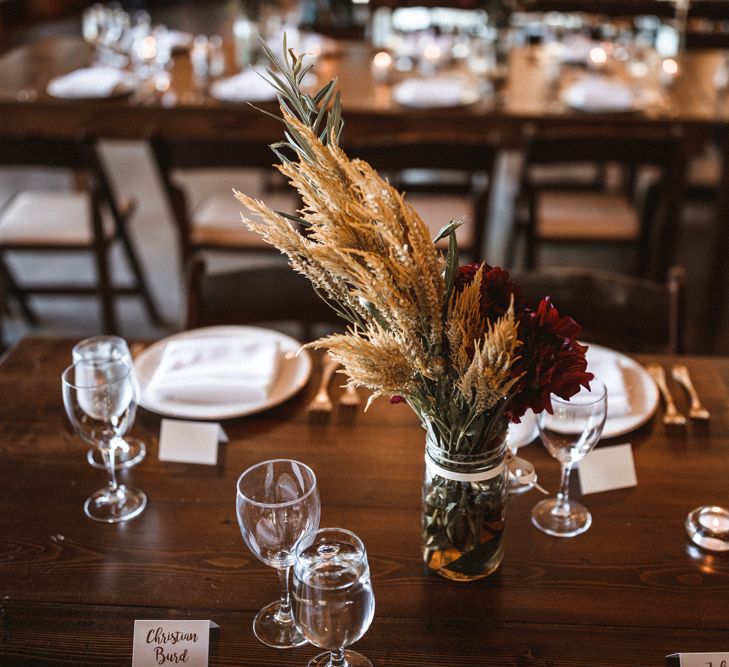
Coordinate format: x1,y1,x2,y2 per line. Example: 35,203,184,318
185,255,344,341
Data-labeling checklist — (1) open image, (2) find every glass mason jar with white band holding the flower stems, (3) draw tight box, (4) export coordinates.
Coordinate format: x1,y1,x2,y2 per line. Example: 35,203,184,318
422,431,509,581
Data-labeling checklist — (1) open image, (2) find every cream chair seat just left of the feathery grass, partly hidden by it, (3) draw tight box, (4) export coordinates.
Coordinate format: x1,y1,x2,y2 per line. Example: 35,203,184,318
190,193,291,250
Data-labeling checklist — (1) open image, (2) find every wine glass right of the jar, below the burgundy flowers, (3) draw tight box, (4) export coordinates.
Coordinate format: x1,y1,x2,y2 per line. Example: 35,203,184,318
532,380,607,537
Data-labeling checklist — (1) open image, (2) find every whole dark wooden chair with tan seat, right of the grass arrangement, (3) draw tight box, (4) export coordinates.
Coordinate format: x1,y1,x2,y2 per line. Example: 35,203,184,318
515,125,683,278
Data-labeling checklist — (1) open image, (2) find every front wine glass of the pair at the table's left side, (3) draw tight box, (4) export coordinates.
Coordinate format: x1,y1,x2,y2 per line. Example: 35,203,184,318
62,359,147,523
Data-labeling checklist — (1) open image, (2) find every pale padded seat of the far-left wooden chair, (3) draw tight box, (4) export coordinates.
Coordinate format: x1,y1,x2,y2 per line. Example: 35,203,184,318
0,190,114,248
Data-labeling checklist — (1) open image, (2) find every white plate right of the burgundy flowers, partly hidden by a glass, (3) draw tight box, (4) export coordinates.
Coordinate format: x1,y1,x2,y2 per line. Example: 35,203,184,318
586,343,658,438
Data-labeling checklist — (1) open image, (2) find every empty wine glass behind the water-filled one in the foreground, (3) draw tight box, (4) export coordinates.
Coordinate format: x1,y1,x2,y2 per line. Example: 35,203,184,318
236,459,321,648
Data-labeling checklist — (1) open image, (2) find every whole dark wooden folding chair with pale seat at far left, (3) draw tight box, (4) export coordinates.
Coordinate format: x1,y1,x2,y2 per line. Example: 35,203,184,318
0,136,160,333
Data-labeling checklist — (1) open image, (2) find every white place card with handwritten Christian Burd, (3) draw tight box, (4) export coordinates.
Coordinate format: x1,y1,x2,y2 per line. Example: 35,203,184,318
132,620,213,667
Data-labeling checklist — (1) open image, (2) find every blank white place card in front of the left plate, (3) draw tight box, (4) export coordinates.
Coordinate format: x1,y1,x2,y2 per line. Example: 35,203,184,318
159,419,228,465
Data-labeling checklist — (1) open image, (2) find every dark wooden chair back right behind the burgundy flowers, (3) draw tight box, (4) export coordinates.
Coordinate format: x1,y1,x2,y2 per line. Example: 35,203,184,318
512,267,686,354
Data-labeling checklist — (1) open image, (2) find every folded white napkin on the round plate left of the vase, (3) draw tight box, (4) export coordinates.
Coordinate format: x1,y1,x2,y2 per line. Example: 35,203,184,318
145,336,281,404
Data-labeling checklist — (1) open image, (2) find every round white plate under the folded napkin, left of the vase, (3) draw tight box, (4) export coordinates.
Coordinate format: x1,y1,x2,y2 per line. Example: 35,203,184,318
134,326,311,419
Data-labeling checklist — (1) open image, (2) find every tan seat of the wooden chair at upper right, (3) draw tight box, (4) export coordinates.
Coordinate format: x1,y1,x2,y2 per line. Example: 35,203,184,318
537,191,640,241
